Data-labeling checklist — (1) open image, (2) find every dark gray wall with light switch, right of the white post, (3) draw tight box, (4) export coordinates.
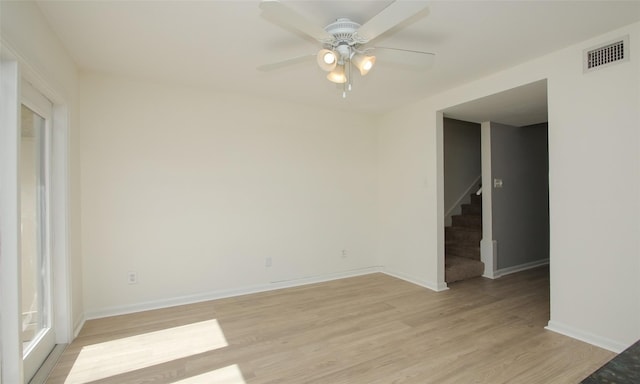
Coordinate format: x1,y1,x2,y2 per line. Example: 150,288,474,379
491,122,549,270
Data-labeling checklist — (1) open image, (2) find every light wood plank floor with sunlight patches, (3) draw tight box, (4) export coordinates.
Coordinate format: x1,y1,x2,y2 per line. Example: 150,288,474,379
47,268,614,384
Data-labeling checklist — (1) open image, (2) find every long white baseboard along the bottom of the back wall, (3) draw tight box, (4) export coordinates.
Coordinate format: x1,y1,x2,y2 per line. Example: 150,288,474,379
82,266,382,320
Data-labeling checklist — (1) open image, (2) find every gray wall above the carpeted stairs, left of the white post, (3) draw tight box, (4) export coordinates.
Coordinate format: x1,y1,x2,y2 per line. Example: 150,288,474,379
444,118,482,212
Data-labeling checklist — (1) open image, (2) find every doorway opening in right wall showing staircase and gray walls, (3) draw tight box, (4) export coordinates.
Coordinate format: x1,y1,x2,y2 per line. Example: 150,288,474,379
440,80,549,283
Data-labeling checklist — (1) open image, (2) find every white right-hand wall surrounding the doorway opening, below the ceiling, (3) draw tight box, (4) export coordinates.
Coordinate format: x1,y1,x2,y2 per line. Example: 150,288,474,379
379,23,640,350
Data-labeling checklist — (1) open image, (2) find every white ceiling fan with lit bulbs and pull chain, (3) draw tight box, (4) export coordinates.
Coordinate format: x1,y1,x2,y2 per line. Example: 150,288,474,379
258,0,434,97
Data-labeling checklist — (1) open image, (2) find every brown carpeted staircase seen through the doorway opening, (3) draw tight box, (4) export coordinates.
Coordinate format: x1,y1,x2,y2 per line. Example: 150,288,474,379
444,193,484,283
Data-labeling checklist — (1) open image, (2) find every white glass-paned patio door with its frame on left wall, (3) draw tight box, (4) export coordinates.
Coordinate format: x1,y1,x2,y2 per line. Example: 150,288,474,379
0,56,73,383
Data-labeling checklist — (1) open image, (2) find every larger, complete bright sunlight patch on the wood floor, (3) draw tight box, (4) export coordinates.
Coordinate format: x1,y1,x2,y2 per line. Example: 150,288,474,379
65,319,228,384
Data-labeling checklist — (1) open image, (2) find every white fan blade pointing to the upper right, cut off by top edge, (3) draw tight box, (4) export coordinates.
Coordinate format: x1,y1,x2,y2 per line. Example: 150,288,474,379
357,1,428,41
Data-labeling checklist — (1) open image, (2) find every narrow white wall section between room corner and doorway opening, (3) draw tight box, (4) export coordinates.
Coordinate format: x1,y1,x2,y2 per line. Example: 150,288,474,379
378,102,446,290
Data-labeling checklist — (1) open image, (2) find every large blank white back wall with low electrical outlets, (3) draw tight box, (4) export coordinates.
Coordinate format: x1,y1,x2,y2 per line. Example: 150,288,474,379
80,74,376,317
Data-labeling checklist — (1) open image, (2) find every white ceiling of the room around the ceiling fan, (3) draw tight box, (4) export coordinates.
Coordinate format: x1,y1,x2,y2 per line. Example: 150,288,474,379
38,0,640,120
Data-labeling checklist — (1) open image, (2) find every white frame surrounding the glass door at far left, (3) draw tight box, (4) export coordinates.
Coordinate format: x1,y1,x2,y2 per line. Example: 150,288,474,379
0,40,73,383
